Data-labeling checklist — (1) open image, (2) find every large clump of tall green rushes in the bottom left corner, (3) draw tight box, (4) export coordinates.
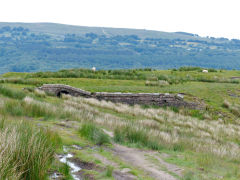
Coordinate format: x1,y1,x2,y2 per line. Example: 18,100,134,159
0,121,61,180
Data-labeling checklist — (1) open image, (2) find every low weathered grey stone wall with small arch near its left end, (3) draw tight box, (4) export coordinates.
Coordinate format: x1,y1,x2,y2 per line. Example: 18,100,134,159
39,84,201,109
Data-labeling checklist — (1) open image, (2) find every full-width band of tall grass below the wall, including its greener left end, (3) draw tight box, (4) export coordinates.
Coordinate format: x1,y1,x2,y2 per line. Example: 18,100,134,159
2,93,240,160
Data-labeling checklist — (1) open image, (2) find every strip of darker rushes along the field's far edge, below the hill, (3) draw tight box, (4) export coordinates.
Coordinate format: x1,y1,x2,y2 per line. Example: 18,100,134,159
23,67,239,85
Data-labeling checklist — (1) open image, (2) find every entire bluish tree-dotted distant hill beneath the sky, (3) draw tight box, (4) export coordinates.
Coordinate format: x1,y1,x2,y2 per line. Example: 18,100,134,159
0,22,240,73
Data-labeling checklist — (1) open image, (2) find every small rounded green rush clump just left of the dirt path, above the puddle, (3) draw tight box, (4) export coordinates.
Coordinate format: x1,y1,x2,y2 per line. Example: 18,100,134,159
79,123,110,145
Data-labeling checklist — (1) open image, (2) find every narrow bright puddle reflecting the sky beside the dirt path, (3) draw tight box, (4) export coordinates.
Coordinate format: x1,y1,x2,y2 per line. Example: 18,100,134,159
58,147,82,180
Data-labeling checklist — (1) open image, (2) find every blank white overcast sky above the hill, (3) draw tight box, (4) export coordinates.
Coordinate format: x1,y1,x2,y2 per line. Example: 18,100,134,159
0,0,240,39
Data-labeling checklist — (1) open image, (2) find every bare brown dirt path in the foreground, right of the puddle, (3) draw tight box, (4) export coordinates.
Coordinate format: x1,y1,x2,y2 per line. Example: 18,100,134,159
51,122,182,180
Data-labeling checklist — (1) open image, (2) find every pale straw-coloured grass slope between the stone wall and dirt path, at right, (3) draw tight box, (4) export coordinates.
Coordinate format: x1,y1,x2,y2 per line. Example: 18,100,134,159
71,98,240,161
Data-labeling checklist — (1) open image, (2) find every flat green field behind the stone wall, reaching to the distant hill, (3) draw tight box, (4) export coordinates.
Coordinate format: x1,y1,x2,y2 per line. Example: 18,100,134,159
3,70,240,119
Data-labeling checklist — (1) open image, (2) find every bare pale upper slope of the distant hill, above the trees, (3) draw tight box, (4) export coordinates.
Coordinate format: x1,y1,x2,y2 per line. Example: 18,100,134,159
0,22,209,39
